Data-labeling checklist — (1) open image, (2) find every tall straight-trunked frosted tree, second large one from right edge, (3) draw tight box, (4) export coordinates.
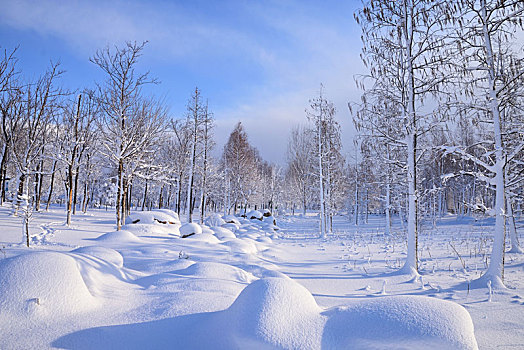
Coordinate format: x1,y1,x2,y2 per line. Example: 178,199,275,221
355,0,449,274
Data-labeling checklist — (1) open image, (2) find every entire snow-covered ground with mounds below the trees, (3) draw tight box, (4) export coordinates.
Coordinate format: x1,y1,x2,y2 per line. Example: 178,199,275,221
0,207,524,349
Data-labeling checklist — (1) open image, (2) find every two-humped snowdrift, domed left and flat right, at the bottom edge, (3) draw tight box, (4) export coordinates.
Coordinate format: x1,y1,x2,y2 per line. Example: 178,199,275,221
215,278,477,349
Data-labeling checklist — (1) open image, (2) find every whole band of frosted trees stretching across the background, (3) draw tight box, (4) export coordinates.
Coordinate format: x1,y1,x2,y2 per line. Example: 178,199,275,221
0,0,524,285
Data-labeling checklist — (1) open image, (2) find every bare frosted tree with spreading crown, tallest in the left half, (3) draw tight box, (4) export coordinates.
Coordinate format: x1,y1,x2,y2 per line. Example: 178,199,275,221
90,42,165,230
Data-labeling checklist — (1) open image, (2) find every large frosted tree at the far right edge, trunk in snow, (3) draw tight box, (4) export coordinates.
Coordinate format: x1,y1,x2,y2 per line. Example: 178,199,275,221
447,0,524,287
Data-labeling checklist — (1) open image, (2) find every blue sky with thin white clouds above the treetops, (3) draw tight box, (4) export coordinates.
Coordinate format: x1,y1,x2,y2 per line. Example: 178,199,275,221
0,0,364,164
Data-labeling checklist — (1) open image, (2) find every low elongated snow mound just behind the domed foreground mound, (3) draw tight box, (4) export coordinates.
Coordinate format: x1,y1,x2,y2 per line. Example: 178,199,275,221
173,262,256,283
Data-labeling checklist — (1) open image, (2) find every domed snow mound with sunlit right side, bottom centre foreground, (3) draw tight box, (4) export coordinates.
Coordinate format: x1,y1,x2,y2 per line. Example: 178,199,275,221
221,277,325,349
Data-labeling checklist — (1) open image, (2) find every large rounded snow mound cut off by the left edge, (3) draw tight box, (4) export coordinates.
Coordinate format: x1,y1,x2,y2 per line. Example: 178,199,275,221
0,252,96,317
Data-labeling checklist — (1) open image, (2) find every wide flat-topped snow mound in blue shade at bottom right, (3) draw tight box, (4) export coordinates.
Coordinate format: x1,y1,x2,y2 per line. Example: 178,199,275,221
323,296,477,349
